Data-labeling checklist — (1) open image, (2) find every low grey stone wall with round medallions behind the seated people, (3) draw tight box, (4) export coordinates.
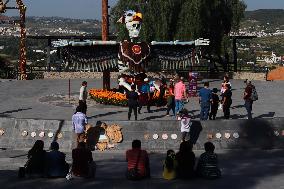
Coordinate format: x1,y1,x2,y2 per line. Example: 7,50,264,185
0,118,284,151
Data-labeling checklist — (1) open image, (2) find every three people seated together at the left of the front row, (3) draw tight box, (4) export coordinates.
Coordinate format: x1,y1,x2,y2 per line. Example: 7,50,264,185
19,140,96,179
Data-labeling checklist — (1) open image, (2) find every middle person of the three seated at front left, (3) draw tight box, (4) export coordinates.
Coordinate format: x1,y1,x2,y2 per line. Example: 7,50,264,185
44,142,69,178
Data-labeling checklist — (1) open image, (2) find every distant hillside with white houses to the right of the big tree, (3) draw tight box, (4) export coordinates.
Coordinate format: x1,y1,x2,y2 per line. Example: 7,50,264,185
231,9,284,66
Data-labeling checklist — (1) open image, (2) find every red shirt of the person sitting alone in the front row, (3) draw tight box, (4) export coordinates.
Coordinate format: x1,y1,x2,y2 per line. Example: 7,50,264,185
126,148,149,177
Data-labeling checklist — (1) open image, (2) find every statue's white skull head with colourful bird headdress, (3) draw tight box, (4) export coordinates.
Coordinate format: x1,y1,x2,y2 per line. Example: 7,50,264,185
119,10,142,38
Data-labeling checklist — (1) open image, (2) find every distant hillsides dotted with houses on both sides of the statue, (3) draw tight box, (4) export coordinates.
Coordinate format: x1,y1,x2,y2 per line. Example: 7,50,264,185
0,9,284,67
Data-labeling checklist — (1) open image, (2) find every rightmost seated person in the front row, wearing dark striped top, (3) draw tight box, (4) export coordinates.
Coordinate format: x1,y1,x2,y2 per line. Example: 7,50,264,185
196,142,221,179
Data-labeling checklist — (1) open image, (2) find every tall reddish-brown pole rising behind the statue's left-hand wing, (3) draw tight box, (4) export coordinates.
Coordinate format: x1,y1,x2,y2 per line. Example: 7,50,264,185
102,0,110,90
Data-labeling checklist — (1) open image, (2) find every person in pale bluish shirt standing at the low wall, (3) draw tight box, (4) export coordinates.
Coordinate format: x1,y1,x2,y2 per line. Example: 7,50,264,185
72,106,88,144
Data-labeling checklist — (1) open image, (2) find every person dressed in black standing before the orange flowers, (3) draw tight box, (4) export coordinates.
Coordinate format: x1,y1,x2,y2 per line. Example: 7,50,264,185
126,85,138,120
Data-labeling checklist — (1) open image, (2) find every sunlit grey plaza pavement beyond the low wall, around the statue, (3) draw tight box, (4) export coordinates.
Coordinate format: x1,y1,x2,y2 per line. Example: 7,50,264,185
0,80,284,124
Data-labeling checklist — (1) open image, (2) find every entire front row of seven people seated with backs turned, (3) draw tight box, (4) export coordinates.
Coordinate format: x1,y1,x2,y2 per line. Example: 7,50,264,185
21,140,221,180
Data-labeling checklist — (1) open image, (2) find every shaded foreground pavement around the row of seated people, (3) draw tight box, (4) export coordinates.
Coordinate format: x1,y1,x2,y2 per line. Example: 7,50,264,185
0,150,284,189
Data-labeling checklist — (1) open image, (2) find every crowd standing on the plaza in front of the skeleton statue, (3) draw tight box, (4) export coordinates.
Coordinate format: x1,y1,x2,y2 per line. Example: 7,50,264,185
124,76,258,120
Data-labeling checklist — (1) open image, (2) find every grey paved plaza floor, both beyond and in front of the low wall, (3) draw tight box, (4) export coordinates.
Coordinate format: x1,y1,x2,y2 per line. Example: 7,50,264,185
0,79,284,189
